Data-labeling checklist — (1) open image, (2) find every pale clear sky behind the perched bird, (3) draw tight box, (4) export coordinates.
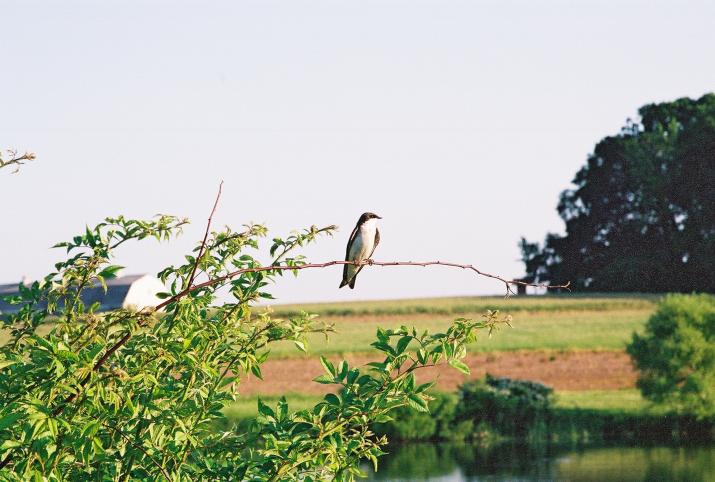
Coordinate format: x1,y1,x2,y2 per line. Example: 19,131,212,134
0,0,715,302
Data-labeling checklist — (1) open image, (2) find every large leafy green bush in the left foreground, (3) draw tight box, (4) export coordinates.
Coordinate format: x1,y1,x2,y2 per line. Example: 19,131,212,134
0,216,510,482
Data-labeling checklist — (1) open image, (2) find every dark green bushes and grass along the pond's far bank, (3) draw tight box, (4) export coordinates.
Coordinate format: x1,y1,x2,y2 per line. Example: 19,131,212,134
375,376,715,448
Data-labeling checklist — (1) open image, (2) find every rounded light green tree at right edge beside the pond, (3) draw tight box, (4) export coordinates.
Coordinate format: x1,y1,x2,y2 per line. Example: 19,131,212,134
627,294,715,416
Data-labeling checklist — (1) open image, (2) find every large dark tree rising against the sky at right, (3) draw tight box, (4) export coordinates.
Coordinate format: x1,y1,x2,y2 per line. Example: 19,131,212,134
520,94,715,292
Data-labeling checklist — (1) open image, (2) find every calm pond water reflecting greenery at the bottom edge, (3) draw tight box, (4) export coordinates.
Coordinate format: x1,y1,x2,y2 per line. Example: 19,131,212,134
364,444,715,482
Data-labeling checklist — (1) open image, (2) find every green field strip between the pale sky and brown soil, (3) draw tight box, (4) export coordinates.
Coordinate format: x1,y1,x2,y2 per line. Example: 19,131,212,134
260,295,658,358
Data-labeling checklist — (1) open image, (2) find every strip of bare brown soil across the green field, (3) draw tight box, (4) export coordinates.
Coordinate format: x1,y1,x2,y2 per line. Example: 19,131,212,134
241,351,636,395
